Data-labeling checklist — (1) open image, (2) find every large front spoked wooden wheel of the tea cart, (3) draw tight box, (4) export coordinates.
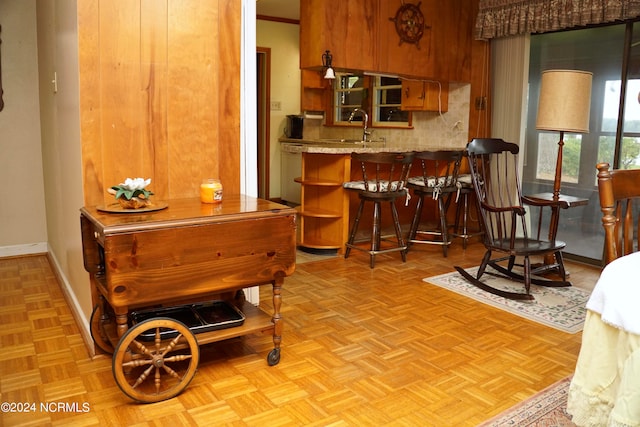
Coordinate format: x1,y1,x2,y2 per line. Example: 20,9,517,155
112,317,200,403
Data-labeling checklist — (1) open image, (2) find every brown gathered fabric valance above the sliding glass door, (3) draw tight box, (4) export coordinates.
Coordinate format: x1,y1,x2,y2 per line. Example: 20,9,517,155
475,0,640,40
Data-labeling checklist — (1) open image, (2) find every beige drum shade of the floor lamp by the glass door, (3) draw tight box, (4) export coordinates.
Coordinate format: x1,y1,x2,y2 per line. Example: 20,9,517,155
536,70,593,133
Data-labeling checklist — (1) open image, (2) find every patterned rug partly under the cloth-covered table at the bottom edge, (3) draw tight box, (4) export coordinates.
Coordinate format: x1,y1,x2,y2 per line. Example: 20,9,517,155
478,376,575,427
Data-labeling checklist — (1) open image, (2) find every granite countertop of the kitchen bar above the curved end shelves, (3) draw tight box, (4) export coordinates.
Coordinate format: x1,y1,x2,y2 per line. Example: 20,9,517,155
278,138,397,154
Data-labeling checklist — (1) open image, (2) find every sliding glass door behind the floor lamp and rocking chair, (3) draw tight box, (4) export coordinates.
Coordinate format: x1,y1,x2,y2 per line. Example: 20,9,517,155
523,22,640,264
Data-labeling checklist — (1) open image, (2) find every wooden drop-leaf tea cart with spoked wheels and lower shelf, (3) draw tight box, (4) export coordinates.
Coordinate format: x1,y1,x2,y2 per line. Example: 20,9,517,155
80,195,296,403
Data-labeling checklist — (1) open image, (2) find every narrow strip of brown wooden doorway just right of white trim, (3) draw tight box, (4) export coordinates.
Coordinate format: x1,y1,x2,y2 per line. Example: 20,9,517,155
256,47,271,199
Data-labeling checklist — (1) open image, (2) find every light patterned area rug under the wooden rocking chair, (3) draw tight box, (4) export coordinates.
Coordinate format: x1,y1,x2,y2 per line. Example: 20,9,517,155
423,267,590,334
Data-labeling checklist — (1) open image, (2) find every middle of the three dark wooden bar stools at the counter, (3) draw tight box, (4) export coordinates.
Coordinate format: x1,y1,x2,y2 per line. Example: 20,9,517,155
407,150,462,257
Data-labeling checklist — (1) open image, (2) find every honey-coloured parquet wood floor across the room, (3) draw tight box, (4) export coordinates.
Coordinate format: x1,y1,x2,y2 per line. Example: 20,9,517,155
0,241,600,426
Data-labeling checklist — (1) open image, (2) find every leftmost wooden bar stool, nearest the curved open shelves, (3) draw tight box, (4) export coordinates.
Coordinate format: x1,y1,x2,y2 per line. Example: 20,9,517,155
343,152,413,268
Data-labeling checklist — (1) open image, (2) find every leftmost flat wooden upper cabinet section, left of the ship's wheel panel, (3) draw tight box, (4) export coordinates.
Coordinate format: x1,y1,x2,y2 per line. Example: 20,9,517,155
300,0,379,71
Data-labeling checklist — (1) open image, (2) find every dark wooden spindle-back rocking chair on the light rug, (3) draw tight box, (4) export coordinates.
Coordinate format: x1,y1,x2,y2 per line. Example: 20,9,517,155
455,138,571,300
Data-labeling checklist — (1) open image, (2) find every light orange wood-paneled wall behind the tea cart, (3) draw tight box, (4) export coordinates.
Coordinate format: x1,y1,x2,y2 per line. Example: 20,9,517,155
78,0,241,205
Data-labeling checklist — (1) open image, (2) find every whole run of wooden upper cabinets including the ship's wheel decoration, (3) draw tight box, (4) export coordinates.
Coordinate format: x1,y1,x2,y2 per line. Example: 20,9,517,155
300,0,477,82
